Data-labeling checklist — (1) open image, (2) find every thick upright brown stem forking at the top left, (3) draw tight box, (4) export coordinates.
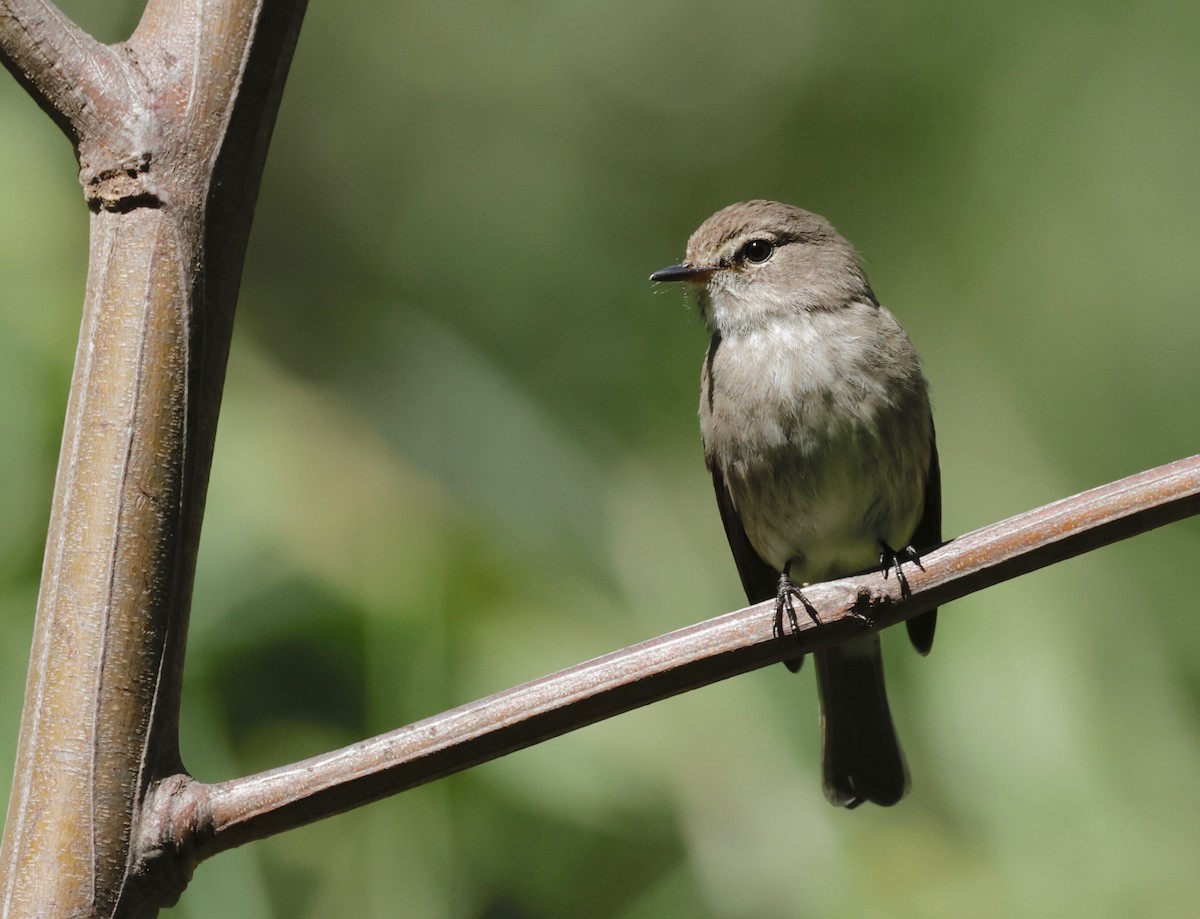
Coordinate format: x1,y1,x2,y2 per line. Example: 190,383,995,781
0,0,305,917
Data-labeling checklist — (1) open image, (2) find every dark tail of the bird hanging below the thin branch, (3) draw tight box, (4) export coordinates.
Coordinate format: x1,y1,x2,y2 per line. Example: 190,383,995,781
814,635,908,807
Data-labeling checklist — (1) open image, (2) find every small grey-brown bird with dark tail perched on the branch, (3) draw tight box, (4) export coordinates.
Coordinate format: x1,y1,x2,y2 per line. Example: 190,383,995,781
650,200,942,807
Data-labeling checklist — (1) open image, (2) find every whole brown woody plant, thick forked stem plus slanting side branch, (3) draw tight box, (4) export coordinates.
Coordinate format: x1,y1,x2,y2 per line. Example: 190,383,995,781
0,0,1200,919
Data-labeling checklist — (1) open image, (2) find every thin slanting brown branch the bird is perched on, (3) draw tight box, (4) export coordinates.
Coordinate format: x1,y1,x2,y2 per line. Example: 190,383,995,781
143,456,1200,860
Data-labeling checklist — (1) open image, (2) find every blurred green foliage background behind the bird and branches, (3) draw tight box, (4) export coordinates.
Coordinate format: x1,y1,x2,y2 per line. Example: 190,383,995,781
0,0,1200,919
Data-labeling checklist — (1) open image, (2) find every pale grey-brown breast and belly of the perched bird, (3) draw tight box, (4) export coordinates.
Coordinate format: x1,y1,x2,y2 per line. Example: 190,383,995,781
700,314,932,582
